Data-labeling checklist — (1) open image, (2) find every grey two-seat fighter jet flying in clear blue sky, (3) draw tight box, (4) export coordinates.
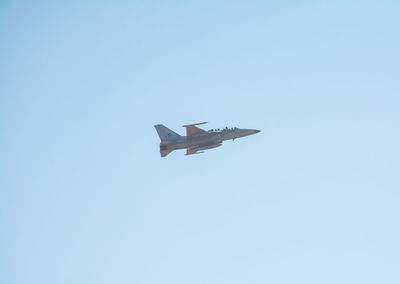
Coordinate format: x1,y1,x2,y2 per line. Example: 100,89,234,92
154,122,260,157
